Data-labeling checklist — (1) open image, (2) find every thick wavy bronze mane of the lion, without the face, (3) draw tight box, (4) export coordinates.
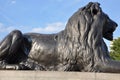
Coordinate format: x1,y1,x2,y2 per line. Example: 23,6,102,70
58,3,109,71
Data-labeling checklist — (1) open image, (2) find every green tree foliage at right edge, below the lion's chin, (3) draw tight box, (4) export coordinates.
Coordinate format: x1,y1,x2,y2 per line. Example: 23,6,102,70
110,38,120,60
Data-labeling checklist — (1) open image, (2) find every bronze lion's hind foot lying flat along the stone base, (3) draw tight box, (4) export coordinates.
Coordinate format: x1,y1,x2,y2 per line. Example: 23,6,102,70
0,59,47,71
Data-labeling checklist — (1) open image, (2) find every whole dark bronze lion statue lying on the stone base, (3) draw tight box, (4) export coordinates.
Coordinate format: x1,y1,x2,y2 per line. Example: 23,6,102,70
0,2,120,73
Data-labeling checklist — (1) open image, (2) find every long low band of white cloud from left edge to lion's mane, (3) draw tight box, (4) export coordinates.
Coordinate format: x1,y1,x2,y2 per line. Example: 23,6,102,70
0,22,65,34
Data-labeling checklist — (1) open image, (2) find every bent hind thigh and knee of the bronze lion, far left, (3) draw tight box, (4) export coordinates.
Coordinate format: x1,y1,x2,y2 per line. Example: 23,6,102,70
0,30,23,61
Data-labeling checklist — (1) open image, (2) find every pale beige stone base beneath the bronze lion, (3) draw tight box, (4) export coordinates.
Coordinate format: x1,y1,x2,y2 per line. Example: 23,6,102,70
0,70,120,80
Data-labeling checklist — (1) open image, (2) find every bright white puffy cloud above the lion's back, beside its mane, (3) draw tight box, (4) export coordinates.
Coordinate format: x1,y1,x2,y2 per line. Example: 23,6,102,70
32,22,65,33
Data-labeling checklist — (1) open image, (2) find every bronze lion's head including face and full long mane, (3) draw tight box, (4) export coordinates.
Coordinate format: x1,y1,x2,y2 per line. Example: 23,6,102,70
61,2,117,71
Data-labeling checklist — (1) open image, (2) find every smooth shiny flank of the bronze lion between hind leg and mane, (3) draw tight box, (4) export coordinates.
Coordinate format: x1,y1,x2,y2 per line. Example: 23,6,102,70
25,34,58,68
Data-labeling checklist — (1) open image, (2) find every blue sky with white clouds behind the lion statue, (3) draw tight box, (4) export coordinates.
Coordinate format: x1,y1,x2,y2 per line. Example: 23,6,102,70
0,0,120,50
